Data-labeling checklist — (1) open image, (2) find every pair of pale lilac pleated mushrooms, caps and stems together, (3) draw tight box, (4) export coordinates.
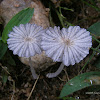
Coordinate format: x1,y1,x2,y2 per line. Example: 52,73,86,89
7,23,92,79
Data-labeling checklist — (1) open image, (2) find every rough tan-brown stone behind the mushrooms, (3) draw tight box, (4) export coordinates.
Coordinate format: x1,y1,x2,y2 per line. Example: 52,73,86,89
0,0,54,71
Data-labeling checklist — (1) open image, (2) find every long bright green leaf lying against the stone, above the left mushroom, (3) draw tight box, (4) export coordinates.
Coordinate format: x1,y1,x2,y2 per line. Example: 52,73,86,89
2,8,34,43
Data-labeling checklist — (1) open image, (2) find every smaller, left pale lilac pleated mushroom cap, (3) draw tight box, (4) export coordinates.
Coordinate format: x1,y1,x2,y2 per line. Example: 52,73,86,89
7,23,44,58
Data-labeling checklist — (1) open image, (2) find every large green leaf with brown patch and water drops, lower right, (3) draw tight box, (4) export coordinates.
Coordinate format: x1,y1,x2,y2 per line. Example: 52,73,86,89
60,71,100,98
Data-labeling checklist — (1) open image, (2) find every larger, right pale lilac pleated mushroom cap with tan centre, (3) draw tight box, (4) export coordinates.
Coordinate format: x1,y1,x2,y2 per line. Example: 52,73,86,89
41,26,92,66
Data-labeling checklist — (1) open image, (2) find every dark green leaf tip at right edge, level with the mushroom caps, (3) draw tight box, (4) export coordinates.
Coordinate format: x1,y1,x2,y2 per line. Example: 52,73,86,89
87,22,100,36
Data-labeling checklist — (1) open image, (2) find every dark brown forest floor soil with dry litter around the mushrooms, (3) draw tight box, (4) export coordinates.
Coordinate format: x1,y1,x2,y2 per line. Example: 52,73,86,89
0,0,100,100
